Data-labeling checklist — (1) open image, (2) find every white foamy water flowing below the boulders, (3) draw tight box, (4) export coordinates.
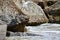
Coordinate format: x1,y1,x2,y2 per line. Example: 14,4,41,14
5,23,60,40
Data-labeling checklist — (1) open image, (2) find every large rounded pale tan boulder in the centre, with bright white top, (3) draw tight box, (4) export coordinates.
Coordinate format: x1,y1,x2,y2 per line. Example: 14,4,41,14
15,1,48,25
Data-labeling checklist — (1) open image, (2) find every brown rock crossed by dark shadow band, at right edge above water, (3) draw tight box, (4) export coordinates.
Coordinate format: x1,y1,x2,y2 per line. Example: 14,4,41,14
44,1,60,23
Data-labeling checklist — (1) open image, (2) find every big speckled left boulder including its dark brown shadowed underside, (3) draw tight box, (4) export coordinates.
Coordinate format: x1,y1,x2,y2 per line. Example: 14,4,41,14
0,0,29,31
